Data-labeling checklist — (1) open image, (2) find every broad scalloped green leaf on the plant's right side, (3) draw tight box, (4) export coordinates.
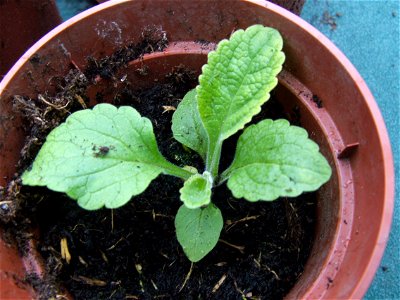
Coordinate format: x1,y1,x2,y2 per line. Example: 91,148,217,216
222,120,332,201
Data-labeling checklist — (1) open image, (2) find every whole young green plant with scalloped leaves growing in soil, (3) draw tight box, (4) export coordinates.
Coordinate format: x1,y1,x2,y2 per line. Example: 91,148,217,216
22,25,331,262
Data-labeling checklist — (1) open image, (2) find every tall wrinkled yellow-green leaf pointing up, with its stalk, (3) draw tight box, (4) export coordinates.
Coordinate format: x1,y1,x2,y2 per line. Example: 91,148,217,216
197,25,285,176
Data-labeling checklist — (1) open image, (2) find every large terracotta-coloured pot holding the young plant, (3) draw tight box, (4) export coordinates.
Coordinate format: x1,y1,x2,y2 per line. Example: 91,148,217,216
0,0,394,299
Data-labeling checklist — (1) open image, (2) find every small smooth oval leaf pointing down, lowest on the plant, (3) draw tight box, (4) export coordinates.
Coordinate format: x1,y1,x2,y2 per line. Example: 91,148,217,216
175,204,224,262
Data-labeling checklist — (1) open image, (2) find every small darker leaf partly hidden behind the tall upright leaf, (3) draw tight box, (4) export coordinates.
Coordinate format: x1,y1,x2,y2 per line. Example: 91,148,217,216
172,90,208,159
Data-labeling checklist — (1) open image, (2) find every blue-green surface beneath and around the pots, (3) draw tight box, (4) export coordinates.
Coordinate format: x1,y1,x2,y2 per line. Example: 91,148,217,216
57,0,400,299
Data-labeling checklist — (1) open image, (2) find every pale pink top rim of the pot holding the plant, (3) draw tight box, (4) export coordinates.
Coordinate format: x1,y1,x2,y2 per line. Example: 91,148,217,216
0,0,395,299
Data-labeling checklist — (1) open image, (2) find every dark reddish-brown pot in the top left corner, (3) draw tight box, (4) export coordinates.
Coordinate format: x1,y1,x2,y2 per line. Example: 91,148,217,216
0,0,61,80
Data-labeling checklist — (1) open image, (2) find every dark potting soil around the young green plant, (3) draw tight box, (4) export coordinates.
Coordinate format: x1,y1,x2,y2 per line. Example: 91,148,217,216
1,31,316,299
